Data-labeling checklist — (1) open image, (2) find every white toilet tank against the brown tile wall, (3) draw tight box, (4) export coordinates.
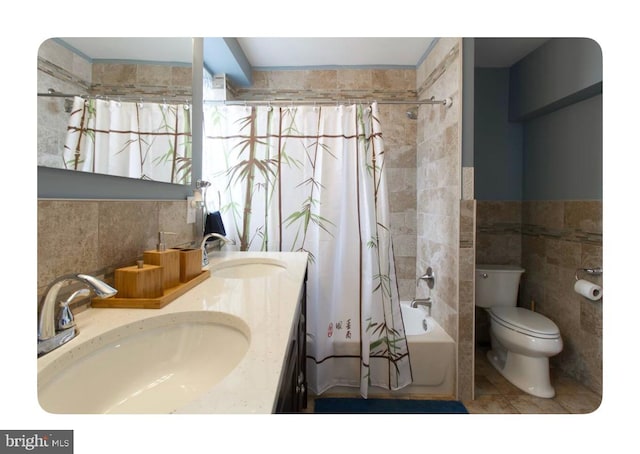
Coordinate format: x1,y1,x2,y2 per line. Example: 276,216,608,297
476,265,524,307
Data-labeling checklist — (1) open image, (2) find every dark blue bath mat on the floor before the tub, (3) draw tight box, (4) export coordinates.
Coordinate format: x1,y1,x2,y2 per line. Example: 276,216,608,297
314,397,469,414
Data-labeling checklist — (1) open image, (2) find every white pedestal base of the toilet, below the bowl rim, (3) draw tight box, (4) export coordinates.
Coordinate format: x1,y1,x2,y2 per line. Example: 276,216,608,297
487,349,556,399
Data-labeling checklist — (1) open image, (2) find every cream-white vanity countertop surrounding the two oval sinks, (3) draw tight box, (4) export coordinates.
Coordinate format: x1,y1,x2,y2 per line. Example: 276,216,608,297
38,251,307,414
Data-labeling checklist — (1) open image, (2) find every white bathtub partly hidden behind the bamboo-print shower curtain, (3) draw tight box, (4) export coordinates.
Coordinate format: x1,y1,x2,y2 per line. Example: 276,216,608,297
309,301,456,398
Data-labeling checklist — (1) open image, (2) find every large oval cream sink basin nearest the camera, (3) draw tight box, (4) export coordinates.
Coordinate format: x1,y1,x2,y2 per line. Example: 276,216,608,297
38,311,250,414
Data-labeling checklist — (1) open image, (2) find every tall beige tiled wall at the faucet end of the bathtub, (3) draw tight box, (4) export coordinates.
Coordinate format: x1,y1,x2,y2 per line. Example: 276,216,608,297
416,39,461,340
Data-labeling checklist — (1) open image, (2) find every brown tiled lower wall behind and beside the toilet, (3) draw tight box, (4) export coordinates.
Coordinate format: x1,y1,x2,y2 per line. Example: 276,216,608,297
476,200,604,394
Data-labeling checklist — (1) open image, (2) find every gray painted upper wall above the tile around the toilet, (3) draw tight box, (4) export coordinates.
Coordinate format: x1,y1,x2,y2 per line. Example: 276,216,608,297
474,38,602,200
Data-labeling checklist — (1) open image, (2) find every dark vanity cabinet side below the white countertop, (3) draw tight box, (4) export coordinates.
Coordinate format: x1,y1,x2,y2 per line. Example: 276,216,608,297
276,274,307,413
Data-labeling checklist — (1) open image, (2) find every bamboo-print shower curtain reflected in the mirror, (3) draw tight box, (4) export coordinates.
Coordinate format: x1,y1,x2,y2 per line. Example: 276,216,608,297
63,97,191,184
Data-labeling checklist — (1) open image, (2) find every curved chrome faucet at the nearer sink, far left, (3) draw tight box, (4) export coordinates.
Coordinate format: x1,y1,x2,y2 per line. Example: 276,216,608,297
38,274,118,356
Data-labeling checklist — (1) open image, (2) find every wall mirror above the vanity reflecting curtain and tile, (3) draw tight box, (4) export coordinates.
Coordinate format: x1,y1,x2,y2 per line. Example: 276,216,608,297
38,37,193,185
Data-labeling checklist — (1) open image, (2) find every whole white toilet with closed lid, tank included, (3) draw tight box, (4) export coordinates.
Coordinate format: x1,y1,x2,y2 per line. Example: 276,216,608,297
476,265,562,398
